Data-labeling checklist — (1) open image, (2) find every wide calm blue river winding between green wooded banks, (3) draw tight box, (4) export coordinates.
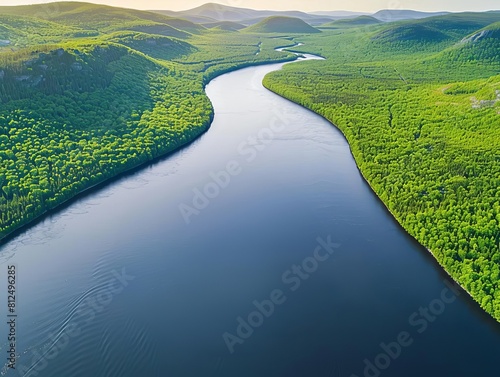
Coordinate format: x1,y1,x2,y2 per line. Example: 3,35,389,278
0,50,500,377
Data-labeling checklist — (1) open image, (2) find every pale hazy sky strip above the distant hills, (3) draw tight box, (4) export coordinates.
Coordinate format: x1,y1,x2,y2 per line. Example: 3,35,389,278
0,0,500,12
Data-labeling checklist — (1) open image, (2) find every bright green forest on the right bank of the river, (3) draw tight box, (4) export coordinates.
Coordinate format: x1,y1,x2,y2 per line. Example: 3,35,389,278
264,14,500,320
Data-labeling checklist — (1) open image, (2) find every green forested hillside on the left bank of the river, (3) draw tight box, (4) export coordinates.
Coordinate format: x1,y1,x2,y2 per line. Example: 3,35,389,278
0,3,293,239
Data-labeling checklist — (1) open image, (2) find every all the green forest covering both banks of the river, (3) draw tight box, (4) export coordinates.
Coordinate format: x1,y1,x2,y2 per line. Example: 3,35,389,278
0,3,500,321
